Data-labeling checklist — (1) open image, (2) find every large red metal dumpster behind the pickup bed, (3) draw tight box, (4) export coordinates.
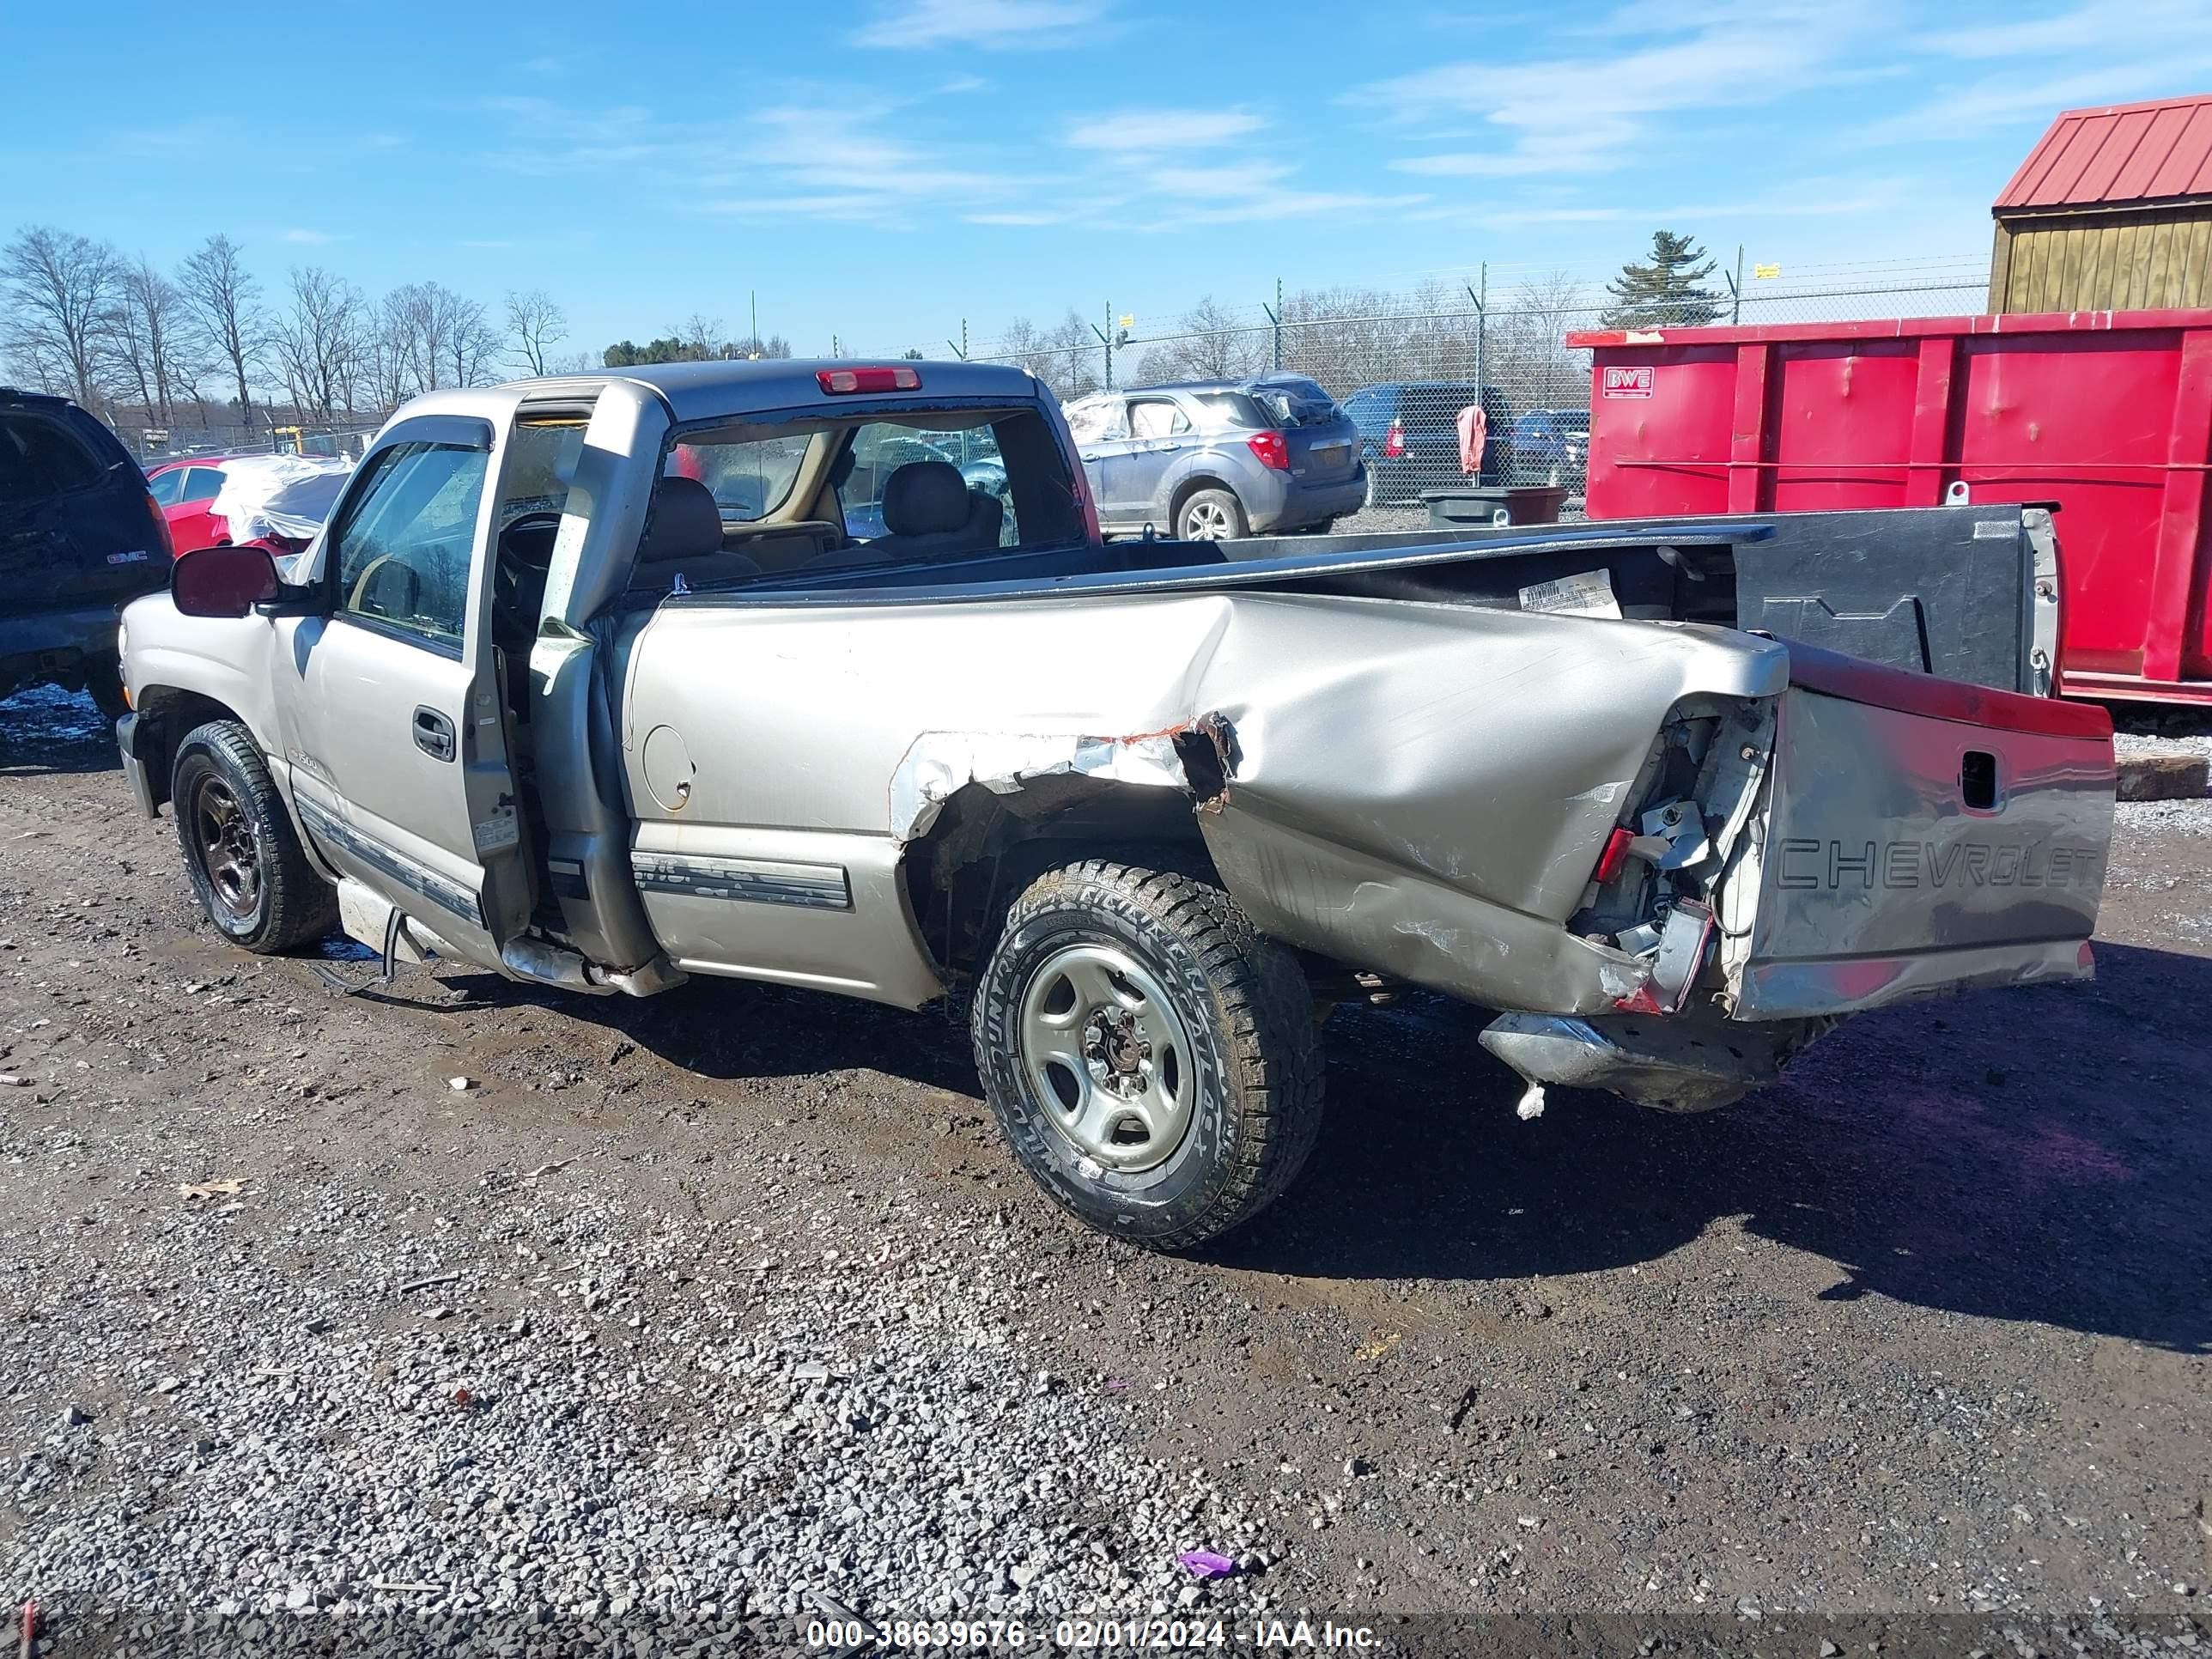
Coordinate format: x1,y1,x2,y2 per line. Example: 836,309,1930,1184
1566,310,2212,703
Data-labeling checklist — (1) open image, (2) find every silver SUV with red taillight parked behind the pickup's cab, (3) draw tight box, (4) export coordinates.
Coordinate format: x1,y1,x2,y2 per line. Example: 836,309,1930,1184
1066,374,1367,542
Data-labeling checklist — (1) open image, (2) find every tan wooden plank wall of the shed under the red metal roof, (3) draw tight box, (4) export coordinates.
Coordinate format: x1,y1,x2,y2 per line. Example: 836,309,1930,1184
1989,201,2212,312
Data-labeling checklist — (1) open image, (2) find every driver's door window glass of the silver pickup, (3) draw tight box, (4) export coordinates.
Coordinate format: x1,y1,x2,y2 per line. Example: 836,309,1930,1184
331,442,491,654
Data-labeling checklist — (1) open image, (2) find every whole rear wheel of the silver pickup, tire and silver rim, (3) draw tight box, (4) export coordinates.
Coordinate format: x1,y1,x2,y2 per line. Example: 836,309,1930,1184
971,860,1321,1249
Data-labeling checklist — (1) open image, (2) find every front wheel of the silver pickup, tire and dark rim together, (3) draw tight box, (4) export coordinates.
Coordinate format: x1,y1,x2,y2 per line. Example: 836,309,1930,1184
168,721,338,956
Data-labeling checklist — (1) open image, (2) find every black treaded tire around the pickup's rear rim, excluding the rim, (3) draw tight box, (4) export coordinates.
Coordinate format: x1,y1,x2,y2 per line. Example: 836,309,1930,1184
969,858,1322,1249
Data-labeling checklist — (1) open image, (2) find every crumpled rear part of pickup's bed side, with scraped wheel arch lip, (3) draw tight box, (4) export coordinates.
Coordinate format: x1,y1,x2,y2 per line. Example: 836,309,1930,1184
871,595,1787,1013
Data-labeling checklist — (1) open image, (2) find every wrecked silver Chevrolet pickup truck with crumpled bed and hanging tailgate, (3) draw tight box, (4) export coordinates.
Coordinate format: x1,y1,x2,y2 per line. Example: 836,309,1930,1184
118,362,2112,1249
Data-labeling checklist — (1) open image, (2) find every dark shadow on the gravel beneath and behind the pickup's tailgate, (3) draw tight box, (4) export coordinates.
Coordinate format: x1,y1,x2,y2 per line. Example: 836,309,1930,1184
1214,945,2212,1354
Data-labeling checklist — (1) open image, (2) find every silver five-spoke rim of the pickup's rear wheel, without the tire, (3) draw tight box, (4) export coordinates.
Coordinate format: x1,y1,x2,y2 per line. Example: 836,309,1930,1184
1018,945,1199,1175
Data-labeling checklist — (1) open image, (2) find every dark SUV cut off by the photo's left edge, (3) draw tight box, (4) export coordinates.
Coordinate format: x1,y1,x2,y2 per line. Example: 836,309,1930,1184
0,387,173,717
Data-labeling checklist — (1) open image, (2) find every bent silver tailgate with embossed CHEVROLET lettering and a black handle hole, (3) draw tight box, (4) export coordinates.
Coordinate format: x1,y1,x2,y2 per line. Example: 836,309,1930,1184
1723,644,2112,1020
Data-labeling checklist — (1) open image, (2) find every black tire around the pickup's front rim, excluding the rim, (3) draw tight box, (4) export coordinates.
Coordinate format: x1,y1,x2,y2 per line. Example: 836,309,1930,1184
168,721,338,956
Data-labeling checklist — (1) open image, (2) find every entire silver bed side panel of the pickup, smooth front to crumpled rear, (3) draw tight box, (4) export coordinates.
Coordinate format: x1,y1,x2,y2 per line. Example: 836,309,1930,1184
622,591,1785,1011
